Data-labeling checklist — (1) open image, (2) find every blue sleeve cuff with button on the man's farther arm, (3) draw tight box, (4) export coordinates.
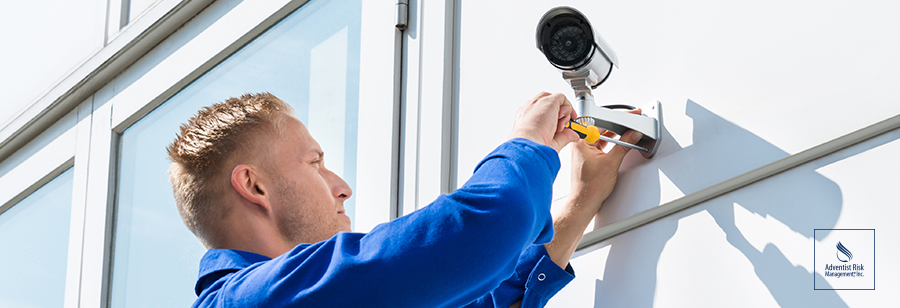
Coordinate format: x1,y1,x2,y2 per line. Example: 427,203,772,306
466,244,575,308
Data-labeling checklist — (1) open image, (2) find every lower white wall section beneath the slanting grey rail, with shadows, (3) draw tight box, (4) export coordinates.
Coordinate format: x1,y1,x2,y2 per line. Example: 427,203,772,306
549,130,900,307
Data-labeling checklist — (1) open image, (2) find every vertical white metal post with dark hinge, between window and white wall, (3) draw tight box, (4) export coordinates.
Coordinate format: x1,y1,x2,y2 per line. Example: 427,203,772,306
395,0,461,217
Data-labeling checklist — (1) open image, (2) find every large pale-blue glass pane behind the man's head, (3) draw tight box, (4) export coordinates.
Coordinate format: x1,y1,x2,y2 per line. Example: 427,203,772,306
110,1,361,307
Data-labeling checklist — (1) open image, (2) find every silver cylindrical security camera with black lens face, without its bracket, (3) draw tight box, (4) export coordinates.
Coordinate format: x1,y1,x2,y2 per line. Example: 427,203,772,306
536,6,619,107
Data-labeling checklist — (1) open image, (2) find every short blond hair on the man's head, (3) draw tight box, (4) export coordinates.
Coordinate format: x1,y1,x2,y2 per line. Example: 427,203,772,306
166,92,293,247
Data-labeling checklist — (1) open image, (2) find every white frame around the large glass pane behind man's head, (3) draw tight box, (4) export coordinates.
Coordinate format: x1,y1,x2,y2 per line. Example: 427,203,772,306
86,0,398,307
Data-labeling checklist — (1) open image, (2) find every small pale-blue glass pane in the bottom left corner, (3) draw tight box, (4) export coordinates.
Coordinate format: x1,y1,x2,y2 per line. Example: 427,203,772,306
0,168,73,307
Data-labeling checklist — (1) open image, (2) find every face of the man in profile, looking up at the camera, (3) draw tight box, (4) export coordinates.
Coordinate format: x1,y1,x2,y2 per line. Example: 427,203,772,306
267,115,352,246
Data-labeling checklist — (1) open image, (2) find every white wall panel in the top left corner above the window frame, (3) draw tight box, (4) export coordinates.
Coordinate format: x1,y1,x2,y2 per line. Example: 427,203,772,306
0,0,106,128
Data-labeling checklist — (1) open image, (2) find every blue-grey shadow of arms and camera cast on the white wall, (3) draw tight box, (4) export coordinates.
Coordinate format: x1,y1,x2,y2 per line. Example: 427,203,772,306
594,100,869,307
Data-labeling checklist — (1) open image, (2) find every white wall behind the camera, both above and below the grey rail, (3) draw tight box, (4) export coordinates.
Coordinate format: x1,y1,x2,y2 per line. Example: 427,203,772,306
457,1,900,307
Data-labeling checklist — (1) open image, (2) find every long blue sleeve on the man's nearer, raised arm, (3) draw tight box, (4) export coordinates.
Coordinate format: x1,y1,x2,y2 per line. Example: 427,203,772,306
198,139,559,307
